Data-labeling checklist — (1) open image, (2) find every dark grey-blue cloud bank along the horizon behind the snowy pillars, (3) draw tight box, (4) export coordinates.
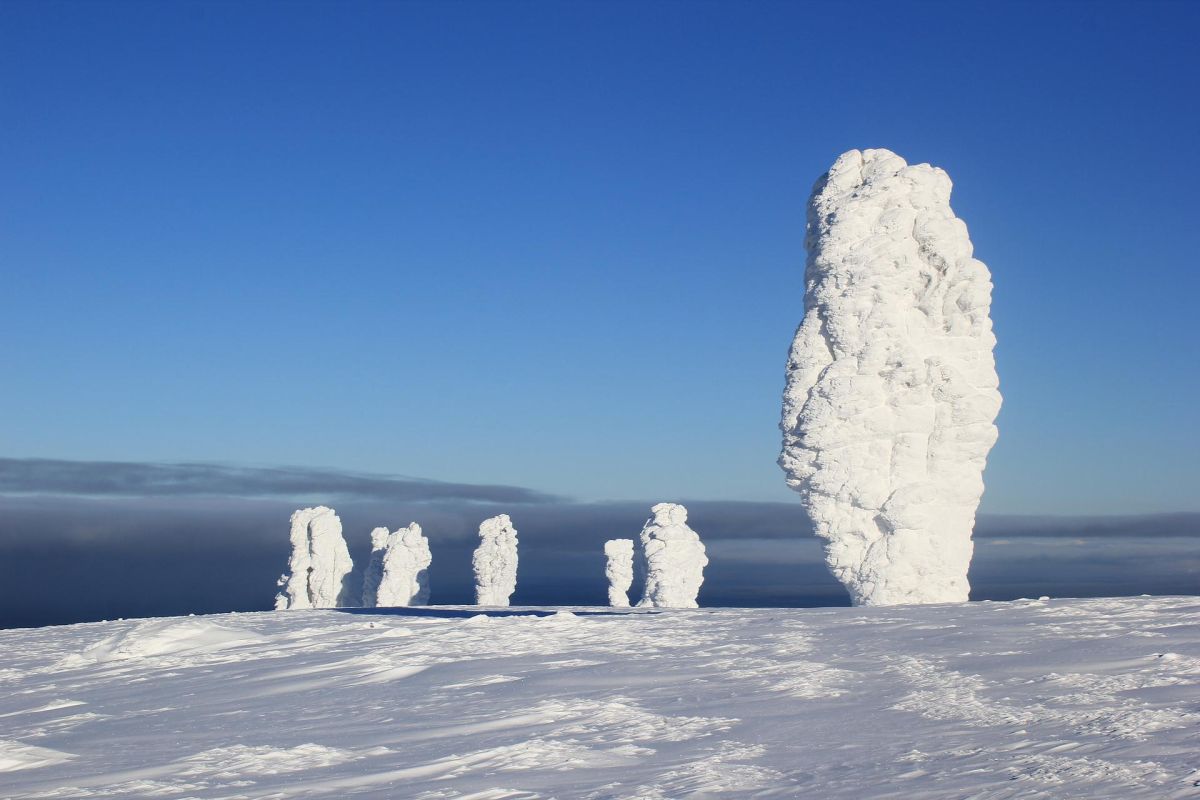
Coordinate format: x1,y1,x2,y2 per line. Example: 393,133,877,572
0,461,1200,627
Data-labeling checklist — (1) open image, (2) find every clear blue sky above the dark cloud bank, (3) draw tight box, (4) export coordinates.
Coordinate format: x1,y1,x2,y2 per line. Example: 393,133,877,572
0,0,1200,513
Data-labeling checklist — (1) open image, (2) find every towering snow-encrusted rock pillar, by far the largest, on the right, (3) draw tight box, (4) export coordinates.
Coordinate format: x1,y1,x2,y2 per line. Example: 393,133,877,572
779,150,1001,606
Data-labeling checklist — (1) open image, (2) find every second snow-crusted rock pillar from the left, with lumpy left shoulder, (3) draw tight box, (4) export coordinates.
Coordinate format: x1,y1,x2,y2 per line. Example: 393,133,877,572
362,522,433,608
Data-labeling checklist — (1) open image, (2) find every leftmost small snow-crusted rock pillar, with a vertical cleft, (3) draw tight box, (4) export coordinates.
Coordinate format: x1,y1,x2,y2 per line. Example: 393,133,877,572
275,506,354,610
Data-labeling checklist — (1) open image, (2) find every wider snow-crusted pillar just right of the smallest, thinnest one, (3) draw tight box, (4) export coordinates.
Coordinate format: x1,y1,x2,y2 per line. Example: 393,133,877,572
637,503,708,608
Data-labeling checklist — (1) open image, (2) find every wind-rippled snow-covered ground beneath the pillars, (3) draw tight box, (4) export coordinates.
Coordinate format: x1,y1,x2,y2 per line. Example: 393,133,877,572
0,597,1200,799
